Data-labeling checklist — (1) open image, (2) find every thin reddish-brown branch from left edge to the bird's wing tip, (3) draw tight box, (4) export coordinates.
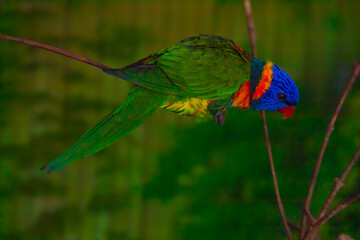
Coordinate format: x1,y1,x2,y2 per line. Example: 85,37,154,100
0,33,111,70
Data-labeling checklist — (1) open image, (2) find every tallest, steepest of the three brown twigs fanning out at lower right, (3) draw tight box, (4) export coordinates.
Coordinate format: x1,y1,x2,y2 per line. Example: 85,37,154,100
300,62,360,239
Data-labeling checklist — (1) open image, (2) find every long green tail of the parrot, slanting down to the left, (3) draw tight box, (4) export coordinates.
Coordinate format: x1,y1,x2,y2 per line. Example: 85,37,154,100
41,86,169,173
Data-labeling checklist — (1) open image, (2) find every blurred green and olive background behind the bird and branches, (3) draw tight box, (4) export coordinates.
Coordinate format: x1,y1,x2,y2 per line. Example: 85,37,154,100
0,0,360,240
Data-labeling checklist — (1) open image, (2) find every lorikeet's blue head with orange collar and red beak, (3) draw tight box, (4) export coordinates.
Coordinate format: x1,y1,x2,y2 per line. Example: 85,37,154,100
250,58,299,118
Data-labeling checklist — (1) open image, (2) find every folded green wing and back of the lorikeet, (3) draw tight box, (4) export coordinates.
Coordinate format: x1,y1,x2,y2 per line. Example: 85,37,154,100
105,35,250,100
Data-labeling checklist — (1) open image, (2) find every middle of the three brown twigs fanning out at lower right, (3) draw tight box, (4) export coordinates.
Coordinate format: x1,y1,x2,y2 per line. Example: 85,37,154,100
317,147,360,220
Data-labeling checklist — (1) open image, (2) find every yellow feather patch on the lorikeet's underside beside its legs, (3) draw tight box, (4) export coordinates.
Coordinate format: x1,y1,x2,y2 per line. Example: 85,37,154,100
161,98,211,117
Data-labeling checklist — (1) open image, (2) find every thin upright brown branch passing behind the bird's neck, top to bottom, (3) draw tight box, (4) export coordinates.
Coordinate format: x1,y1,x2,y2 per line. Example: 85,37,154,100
244,0,292,240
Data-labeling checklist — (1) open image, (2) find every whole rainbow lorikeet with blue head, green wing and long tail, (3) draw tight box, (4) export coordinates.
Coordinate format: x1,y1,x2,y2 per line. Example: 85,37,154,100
42,35,299,173
